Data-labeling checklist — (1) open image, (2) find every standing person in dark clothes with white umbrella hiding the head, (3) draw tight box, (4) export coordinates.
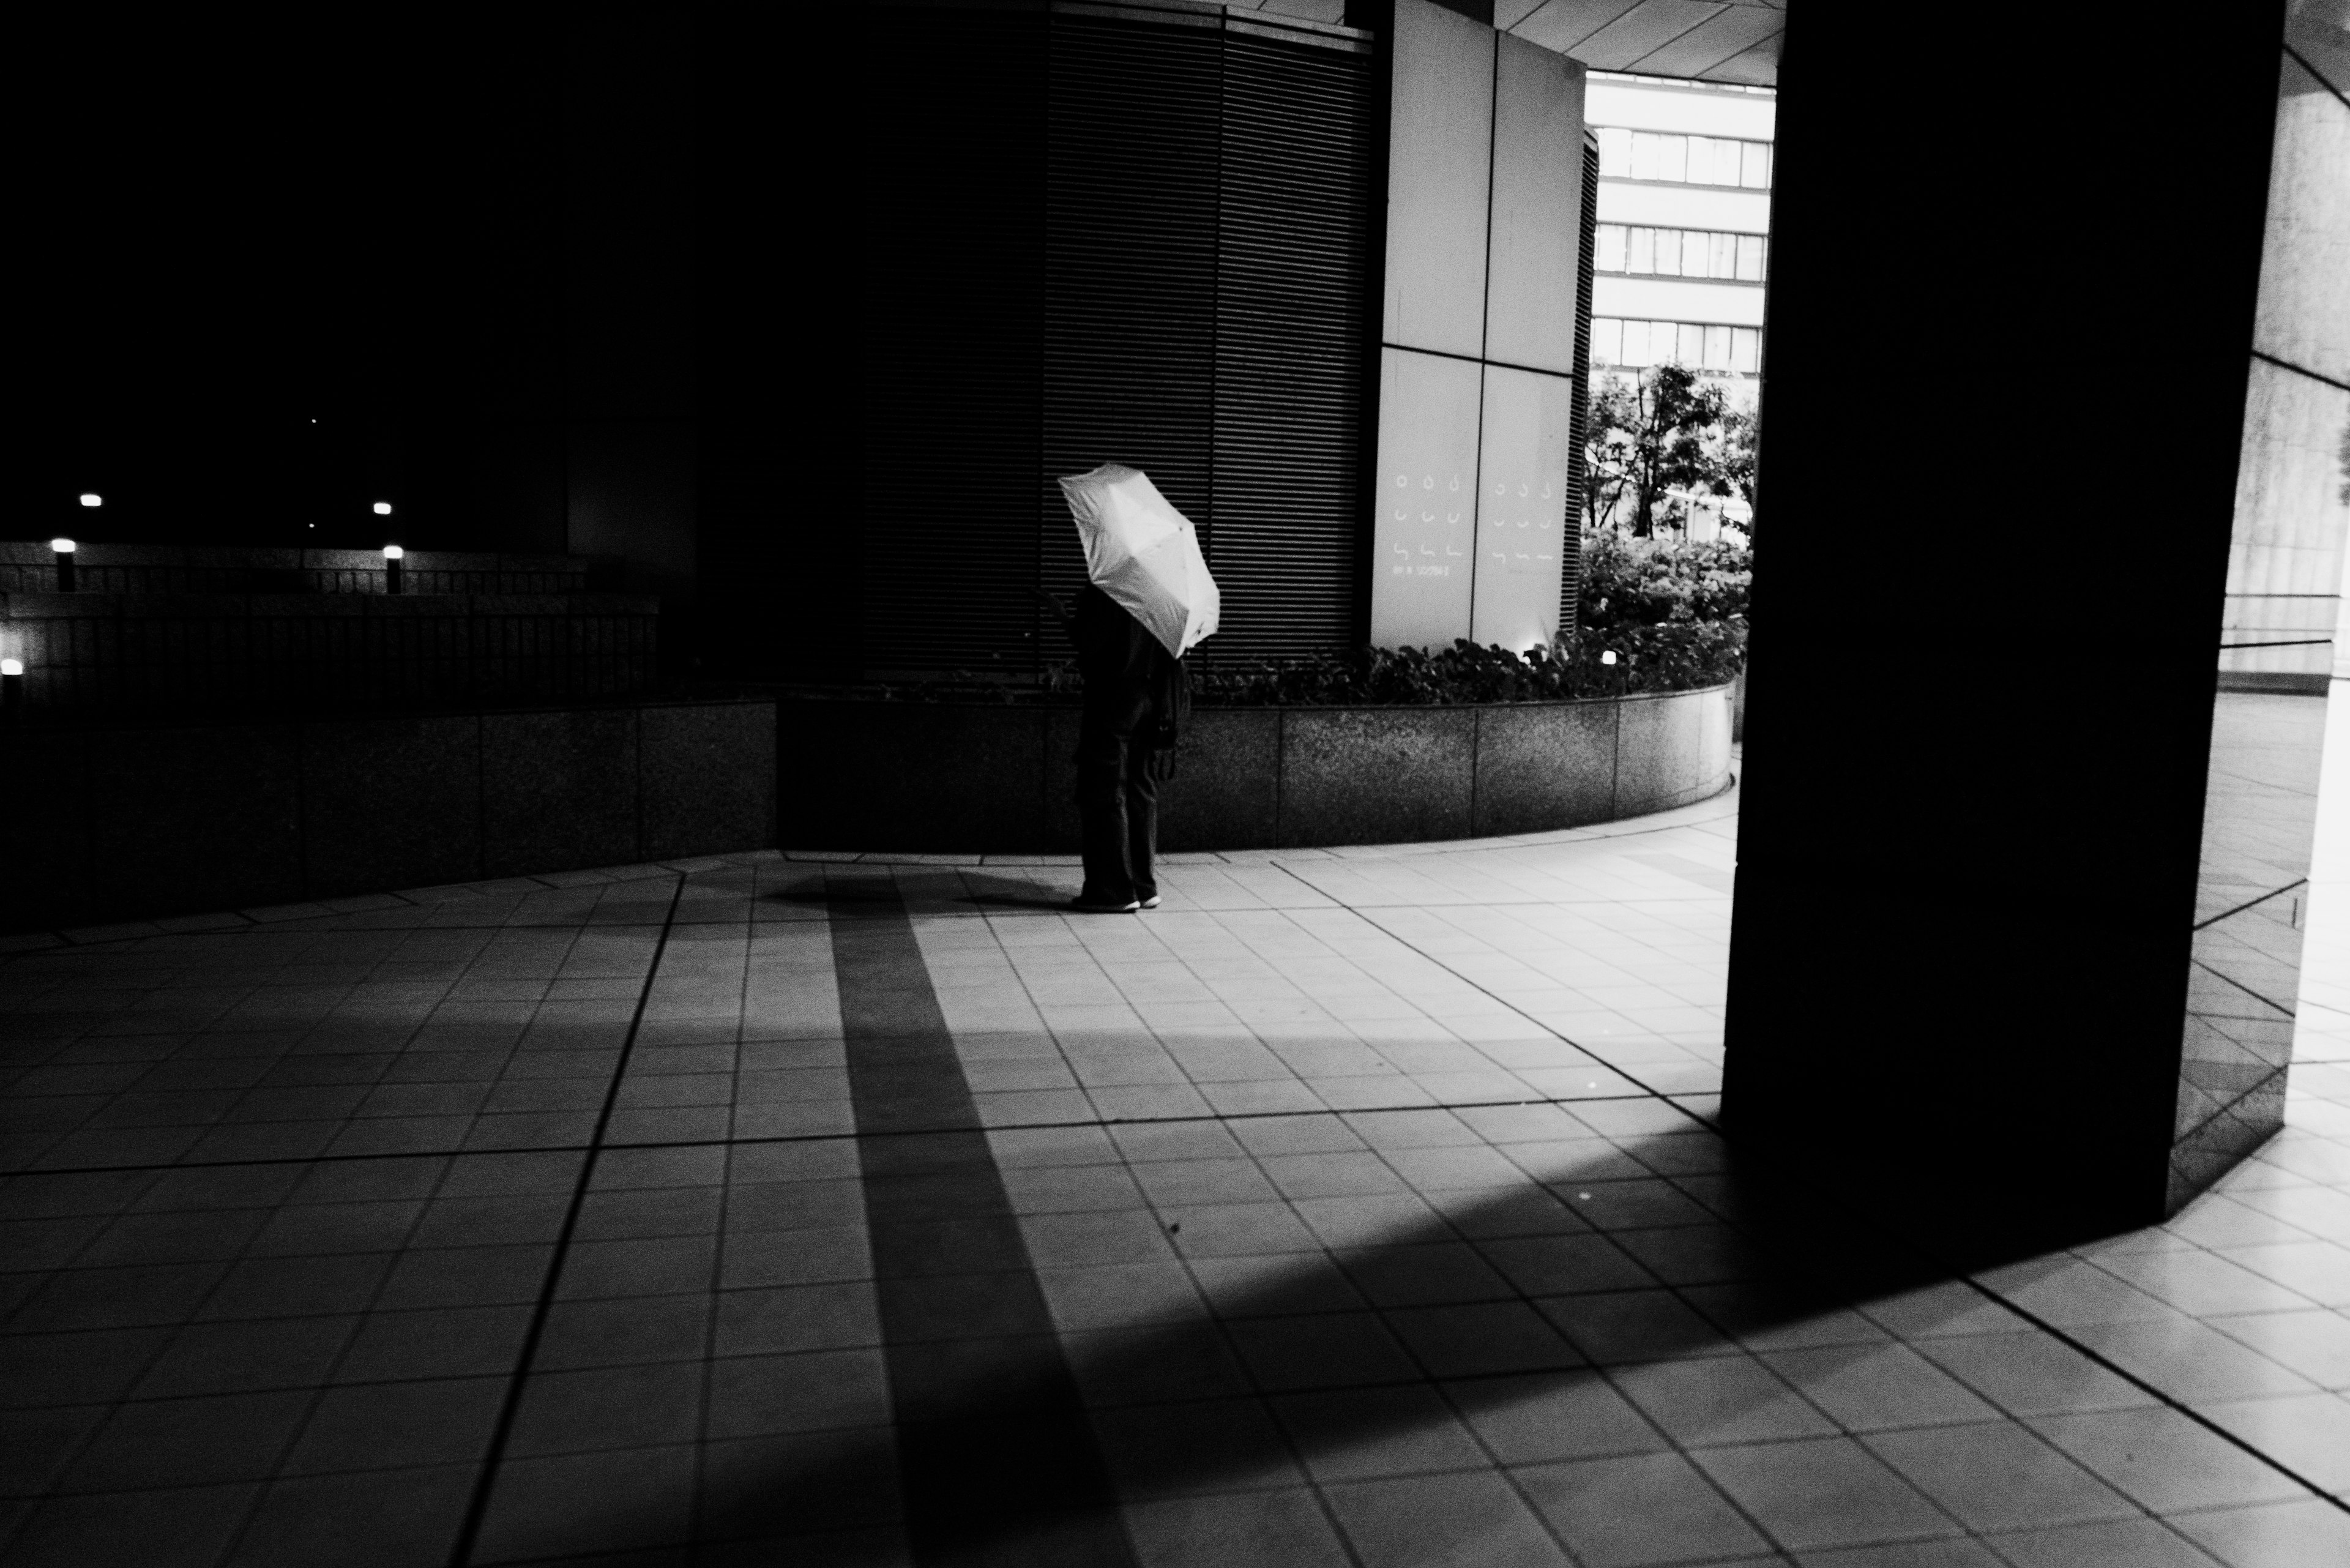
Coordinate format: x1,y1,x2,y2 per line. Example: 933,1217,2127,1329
1041,463,1220,914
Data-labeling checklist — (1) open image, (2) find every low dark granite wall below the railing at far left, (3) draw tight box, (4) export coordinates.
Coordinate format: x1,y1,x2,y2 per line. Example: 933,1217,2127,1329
0,698,775,931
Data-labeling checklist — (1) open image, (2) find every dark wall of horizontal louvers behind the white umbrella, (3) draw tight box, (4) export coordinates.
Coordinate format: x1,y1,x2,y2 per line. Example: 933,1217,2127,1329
862,7,1382,674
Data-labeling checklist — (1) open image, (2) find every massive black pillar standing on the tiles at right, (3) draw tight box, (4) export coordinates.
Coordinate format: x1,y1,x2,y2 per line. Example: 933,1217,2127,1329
1725,5,2338,1250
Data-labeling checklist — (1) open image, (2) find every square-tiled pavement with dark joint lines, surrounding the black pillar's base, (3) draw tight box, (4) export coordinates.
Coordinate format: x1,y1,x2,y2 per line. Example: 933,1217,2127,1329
0,726,2350,1568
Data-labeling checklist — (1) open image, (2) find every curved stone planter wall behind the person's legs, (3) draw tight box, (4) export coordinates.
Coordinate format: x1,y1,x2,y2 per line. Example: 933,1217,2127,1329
778,687,1732,853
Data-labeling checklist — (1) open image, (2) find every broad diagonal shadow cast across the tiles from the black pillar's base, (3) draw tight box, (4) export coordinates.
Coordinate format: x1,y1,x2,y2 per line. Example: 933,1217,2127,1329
538,1124,2152,1566
